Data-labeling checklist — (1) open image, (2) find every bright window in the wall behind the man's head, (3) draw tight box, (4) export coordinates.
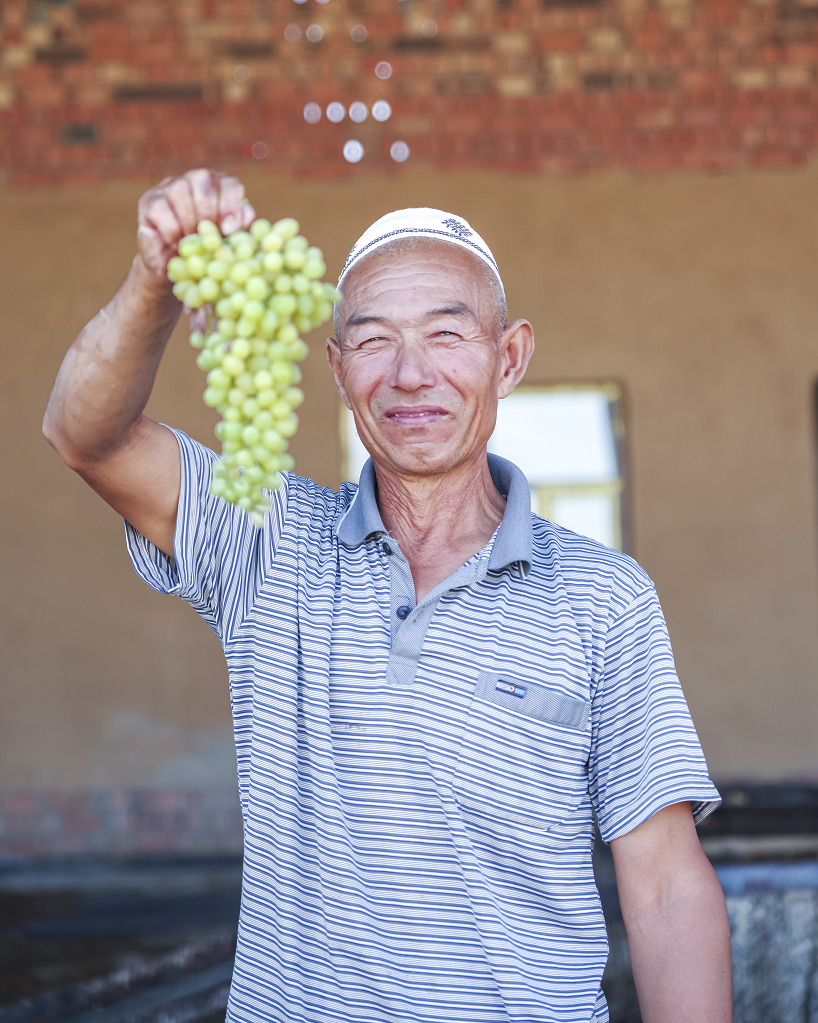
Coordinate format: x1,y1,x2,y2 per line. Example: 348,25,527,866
342,384,626,550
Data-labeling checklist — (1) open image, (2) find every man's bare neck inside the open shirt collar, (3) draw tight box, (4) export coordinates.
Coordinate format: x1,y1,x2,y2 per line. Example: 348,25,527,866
375,454,505,601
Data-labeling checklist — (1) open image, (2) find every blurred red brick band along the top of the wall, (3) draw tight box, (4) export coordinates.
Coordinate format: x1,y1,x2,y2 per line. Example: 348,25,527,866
0,0,818,185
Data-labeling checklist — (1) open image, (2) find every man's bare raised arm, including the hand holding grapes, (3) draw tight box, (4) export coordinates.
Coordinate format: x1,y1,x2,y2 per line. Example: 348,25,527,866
43,170,255,555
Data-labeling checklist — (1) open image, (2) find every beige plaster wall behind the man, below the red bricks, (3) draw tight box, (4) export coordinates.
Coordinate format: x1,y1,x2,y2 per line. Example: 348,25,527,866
0,167,818,790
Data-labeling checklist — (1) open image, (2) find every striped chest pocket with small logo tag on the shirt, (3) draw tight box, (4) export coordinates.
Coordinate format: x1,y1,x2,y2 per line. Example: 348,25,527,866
453,671,590,831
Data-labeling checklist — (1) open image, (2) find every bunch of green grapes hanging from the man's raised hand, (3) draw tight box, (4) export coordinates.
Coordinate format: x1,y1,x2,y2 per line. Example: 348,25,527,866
168,218,340,526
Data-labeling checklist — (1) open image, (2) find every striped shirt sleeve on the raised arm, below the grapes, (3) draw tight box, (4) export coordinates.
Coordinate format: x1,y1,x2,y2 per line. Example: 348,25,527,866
125,430,287,643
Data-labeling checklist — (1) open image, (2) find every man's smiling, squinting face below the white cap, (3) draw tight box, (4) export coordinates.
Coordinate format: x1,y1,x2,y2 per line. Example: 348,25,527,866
328,239,518,478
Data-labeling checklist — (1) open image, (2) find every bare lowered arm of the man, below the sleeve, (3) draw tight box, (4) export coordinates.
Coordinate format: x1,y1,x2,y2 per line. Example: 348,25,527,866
610,803,732,1023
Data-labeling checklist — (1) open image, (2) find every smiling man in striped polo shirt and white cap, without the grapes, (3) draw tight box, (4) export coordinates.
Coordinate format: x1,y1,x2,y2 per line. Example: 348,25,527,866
45,171,731,1023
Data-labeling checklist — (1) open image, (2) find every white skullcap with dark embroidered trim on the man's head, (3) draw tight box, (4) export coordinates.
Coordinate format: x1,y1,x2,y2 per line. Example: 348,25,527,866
338,206,505,294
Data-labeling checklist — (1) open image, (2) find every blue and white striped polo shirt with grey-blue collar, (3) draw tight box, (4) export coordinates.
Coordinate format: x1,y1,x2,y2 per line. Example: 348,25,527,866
128,434,719,1023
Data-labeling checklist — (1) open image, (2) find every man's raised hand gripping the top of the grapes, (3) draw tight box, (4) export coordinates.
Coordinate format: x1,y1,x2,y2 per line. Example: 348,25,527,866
136,169,256,286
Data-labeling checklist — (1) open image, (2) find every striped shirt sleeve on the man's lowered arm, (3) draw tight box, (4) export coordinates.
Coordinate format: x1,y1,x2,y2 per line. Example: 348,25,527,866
589,587,721,842
